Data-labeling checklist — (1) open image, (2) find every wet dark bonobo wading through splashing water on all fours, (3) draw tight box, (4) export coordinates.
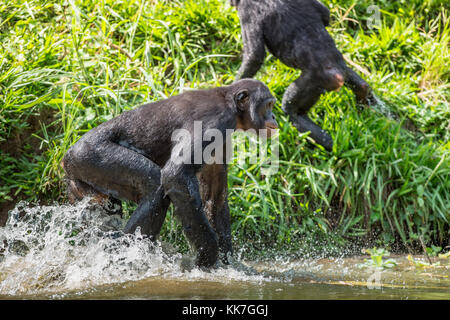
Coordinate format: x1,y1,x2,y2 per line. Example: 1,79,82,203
62,79,277,267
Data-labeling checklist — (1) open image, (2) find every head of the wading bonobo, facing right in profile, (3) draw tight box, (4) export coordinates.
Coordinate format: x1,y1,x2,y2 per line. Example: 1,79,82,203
230,79,278,137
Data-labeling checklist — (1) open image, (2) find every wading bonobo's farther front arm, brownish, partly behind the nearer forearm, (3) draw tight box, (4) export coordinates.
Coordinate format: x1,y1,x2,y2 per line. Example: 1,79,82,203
197,164,233,264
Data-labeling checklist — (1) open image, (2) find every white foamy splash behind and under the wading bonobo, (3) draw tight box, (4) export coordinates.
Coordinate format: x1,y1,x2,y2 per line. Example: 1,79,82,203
0,199,263,295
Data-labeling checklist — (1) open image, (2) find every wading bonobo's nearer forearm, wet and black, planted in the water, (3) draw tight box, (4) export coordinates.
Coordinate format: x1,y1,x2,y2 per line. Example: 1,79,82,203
161,161,218,267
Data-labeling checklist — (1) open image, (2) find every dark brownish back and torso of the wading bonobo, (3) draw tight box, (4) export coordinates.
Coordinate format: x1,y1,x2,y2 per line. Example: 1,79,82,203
70,87,235,166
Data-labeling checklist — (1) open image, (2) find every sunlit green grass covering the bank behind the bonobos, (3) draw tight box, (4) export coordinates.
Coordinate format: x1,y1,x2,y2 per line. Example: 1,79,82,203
0,0,450,255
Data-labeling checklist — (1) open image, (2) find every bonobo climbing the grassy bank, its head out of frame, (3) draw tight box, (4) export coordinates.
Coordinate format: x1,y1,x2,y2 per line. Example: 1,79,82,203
231,0,373,150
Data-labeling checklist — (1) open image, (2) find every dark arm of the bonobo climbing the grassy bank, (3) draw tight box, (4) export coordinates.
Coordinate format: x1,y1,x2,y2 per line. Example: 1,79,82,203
236,10,266,80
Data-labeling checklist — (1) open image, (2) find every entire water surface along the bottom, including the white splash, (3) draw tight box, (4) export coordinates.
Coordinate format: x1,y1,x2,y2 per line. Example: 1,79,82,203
0,201,450,299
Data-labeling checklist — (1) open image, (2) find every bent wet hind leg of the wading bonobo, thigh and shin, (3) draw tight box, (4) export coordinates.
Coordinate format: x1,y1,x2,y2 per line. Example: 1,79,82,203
63,140,168,238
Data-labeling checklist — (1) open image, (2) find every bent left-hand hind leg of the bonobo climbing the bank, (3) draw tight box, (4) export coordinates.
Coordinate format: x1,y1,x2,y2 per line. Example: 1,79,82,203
283,73,333,151
